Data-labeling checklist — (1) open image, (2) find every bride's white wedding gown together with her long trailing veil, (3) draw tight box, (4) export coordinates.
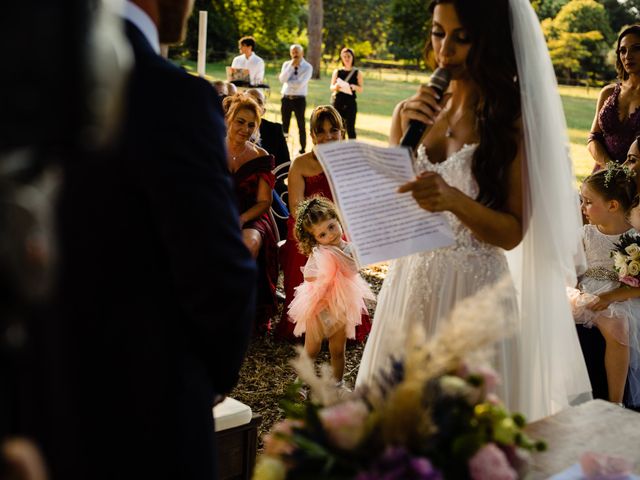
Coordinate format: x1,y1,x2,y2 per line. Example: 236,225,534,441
357,0,591,421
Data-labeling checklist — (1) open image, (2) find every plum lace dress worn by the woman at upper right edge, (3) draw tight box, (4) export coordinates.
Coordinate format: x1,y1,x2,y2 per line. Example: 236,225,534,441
594,83,640,166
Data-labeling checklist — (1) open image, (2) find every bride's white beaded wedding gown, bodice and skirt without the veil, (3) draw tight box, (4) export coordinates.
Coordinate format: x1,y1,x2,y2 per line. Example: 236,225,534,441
356,145,518,408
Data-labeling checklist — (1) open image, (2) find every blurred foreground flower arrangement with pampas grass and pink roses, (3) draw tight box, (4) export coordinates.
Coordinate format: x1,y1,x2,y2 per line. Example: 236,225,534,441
254,281,545,480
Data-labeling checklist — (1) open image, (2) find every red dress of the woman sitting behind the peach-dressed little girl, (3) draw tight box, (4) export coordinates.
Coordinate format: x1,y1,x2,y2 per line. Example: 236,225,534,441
275,173,371,342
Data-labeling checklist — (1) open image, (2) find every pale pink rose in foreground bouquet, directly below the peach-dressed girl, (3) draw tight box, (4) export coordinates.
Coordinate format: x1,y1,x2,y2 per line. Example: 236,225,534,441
318,400,369,450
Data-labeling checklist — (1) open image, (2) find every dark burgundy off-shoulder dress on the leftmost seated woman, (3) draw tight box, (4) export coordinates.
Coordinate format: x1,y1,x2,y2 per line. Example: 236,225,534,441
233,155,278,332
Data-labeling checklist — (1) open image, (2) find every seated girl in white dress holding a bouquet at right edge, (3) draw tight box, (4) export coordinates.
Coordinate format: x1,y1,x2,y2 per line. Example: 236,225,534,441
568,167,640,405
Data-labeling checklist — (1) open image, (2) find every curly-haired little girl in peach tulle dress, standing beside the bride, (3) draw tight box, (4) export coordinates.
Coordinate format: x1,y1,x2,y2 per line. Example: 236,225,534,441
289,196,375,385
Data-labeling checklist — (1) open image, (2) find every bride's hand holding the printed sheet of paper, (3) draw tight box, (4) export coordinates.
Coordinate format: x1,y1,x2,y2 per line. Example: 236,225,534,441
398,172,462,212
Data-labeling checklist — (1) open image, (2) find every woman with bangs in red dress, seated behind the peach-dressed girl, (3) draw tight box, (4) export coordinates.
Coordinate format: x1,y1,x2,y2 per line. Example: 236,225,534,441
275,105,371,342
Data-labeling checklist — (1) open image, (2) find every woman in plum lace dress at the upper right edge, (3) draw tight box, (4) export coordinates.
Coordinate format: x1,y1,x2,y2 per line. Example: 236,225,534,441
587,25,640,171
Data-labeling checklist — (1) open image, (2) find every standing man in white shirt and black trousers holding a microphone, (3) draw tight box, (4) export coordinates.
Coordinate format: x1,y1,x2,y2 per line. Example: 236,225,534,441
278,44,313,153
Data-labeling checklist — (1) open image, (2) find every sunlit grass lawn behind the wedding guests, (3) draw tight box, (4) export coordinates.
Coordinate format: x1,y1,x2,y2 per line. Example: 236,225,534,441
182,62,599,182
